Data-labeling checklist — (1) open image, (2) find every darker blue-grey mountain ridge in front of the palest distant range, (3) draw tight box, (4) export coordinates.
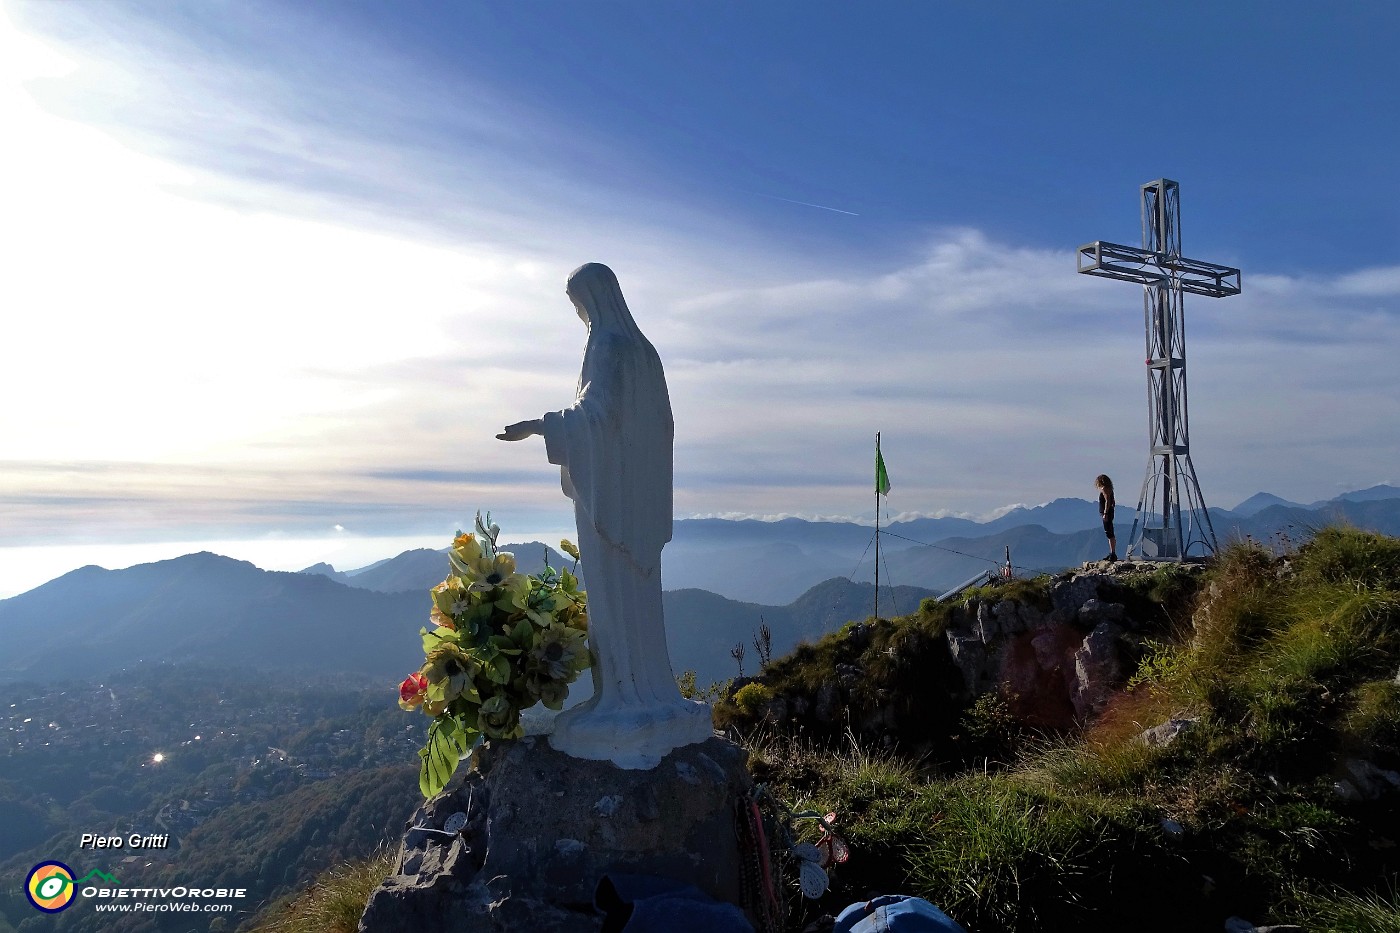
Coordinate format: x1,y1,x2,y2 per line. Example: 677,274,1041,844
0,552,932,684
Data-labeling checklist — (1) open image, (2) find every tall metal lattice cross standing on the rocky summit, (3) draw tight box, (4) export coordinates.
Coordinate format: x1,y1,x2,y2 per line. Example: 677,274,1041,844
1079,178,1239,560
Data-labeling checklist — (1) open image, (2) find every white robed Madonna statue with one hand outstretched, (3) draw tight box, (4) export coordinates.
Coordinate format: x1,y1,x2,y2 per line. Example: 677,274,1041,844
497,262,713,768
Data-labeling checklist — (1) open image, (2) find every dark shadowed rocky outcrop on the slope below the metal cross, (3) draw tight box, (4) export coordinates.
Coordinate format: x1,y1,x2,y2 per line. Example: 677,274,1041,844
721,560,1205,755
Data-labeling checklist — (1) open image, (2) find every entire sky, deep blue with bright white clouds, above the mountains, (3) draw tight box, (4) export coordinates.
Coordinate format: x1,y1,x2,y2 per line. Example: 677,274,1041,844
0,0,1400,597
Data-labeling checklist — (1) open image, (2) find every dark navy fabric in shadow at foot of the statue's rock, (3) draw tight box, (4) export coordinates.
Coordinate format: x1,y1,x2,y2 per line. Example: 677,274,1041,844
594,874,755,933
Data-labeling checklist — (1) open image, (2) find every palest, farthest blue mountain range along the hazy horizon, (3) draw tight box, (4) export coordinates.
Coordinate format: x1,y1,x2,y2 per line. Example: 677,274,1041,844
0,483,1400,605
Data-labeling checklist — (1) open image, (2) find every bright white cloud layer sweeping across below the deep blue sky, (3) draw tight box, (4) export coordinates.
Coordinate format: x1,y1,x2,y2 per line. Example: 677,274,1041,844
0,7,1400,574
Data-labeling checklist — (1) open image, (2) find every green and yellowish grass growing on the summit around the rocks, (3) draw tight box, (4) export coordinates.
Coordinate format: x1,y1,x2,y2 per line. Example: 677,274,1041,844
259,530,1400,933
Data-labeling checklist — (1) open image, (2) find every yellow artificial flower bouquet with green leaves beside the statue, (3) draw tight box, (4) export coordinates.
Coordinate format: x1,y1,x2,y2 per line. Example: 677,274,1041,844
399,513,589,797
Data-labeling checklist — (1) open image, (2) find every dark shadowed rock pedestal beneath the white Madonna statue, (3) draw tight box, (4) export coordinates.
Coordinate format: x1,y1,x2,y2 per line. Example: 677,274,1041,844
360,738,753,933
